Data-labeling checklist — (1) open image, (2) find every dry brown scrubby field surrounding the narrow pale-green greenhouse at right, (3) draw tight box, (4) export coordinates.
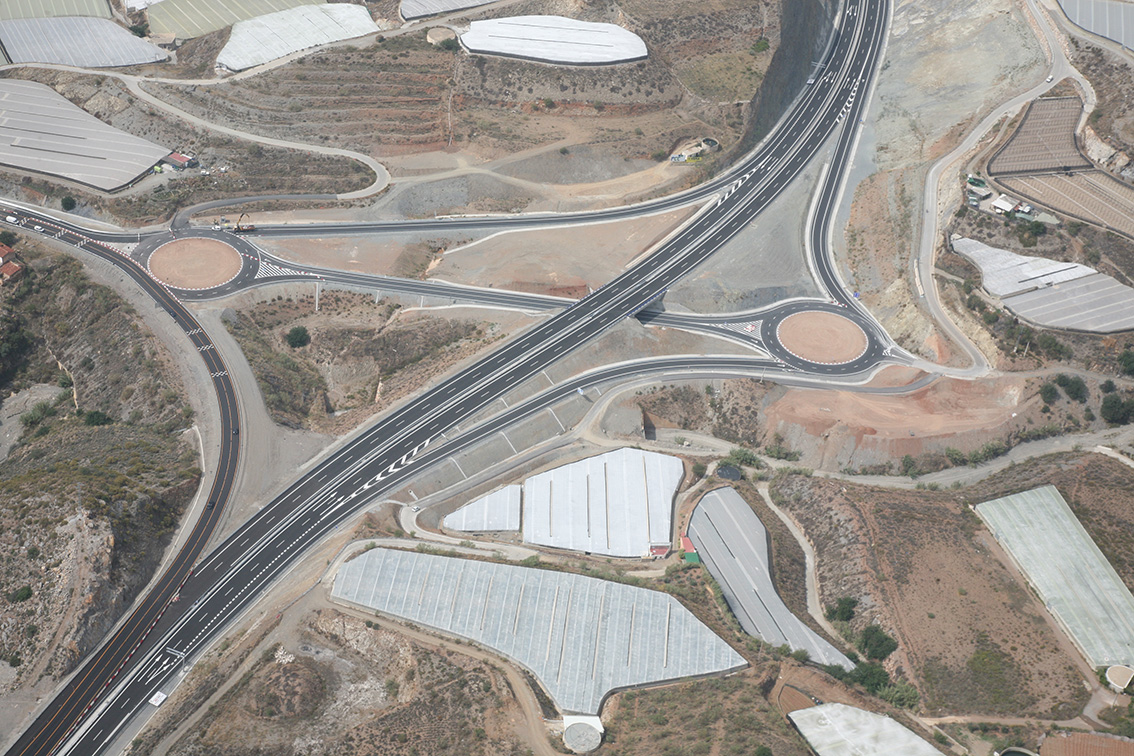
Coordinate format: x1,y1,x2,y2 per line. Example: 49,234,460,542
772,453,1134,720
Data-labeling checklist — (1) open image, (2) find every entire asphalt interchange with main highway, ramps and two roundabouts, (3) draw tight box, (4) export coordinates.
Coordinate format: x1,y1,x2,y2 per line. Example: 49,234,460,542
5,0,911,756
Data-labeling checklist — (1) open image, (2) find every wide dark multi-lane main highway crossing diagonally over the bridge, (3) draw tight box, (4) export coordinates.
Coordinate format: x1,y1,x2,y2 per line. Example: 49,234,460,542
8,0,889,756
